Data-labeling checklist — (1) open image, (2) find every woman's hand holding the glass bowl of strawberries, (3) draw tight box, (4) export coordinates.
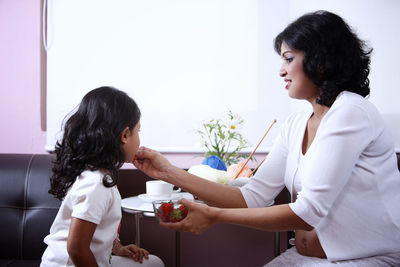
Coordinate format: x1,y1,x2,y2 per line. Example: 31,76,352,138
160,198,217,234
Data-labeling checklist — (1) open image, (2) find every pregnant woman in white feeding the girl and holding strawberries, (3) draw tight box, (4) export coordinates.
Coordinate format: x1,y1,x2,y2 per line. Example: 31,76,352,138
134,11,400,265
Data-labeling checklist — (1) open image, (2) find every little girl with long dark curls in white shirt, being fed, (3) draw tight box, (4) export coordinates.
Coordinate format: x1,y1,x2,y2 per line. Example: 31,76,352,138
41,87,164,267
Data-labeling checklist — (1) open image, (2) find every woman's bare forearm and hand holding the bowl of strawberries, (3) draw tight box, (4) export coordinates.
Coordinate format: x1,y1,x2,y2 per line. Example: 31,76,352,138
161,199,313,234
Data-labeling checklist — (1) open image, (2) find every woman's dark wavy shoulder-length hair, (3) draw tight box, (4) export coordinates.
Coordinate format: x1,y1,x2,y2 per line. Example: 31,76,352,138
274,11,372,107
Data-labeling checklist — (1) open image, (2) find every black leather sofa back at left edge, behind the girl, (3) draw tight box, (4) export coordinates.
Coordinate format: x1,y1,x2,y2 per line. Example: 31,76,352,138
0,154,61,267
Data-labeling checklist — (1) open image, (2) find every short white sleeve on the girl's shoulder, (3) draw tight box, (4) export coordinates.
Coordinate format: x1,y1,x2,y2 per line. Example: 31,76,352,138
71,177,112,224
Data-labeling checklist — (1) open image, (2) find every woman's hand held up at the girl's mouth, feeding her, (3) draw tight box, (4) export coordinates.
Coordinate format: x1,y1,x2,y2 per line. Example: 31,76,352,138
132,147,173,180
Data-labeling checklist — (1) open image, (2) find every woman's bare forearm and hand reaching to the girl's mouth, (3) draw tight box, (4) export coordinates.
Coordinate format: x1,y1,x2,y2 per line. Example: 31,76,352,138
133,147,247,208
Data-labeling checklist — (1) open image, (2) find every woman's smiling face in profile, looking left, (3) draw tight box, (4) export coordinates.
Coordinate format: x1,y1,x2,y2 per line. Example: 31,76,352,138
279,41,319,102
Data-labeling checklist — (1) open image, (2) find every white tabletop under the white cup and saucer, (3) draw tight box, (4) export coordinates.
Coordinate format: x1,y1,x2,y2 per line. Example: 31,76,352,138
121,193,193,216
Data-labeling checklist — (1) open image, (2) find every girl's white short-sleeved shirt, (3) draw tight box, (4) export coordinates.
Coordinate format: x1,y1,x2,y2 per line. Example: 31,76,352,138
40,171,121,266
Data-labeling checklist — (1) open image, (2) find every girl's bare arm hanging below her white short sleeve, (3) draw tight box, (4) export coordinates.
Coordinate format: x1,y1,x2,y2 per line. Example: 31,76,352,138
67,217,98,267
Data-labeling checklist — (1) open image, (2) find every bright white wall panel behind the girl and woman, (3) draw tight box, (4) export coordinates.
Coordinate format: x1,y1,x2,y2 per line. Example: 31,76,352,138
47,0,400,155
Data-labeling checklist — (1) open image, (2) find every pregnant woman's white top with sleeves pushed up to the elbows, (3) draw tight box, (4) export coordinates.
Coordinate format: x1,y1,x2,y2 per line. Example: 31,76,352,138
241,92,400,261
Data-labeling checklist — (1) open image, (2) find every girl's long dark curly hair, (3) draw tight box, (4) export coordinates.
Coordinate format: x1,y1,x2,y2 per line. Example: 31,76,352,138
49,87,140,199
